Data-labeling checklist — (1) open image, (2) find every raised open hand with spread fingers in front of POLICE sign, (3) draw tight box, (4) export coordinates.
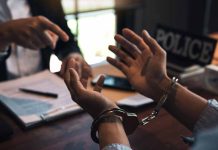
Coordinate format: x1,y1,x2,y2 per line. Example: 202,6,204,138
107,29,170,100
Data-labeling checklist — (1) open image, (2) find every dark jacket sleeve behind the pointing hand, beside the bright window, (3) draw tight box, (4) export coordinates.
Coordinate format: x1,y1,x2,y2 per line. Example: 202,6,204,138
29,0,81,59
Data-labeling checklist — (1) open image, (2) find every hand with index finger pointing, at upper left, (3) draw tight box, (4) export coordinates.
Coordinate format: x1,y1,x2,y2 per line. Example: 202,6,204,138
0,16,69,49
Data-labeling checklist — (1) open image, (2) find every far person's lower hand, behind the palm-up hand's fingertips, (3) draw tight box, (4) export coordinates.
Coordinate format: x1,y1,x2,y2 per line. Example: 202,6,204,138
60,53,92,78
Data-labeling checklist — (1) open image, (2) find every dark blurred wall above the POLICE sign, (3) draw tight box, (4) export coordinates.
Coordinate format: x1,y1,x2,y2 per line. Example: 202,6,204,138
129,0,218,35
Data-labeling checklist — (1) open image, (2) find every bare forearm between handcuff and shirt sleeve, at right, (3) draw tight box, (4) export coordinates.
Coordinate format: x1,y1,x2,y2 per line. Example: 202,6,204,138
160,76,207,130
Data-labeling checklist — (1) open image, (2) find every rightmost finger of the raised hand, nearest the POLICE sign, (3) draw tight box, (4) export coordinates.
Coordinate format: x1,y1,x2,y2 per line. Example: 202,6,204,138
142,30,164,55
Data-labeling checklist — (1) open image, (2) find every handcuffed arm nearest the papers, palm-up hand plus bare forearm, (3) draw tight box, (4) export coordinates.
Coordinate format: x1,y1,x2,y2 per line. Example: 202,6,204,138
65,60,129,149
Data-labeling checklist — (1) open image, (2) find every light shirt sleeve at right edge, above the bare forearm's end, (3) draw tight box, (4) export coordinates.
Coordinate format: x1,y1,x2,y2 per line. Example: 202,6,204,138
194,99,218,133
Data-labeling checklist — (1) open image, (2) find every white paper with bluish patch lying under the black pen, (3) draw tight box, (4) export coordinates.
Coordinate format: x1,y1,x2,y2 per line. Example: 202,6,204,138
0,70,82,127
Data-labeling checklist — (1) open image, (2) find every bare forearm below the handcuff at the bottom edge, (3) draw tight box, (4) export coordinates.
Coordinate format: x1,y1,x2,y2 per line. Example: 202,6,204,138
98,118,130,149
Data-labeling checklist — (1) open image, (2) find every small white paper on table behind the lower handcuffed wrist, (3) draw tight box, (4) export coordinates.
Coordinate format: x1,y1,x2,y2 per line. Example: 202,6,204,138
117,94,153,107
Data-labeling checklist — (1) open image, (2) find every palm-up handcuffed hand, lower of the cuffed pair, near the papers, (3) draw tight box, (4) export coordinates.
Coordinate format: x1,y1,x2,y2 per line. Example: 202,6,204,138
64,68,118,118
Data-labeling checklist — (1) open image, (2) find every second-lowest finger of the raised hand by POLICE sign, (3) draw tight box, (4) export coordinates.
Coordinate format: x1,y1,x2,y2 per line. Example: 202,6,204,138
108,45,132,66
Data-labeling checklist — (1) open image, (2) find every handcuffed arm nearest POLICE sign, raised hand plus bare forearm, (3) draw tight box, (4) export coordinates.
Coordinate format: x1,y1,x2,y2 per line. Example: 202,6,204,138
107,29,207,129
